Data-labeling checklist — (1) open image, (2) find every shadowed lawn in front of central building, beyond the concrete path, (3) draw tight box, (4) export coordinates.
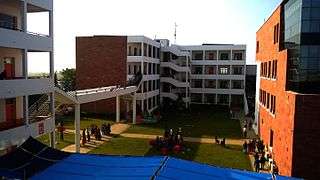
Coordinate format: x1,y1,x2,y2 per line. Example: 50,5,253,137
127,105,241,139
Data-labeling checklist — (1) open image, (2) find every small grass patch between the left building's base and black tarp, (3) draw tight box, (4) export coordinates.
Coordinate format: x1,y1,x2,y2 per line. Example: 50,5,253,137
37,133,75,149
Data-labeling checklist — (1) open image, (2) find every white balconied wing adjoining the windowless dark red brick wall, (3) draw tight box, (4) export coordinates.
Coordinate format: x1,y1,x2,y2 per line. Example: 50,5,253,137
127,36,160,112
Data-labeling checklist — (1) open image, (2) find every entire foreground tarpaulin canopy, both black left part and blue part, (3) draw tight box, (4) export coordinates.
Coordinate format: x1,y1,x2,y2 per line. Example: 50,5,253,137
0,138,300,180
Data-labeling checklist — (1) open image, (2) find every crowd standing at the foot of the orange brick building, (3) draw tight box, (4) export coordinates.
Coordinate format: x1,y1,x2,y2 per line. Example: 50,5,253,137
243,139,278,174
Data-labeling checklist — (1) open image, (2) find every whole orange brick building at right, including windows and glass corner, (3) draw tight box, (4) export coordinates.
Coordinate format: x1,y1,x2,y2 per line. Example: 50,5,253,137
256,0,320,179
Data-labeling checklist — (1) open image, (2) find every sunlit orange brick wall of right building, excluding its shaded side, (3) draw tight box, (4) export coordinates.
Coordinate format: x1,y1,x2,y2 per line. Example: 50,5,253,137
256,7,295,176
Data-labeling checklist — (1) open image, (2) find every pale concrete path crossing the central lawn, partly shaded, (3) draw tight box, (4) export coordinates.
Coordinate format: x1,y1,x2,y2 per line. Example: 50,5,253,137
121,133,246,146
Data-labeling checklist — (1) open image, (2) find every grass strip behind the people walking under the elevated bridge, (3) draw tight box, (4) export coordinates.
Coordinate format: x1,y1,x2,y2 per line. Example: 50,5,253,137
56,116,114,129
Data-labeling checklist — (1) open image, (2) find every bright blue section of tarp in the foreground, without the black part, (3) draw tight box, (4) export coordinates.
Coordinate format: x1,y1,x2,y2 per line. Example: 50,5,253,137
31,154,291,180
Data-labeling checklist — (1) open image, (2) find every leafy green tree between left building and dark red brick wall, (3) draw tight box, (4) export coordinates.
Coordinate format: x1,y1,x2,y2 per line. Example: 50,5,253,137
60,68,76,91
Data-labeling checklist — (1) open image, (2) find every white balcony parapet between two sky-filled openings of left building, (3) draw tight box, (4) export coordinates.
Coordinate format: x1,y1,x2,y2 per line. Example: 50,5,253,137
0,28,53,52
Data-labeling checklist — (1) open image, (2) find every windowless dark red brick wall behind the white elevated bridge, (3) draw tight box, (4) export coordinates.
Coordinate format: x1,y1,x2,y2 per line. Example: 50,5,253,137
76,36,127,113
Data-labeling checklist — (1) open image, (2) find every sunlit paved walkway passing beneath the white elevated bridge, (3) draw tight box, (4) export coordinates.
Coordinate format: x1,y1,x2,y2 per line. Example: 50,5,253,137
62,123,130,153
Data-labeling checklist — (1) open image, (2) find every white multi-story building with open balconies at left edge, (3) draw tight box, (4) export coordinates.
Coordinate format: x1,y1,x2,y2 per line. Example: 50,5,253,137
0,0,55,151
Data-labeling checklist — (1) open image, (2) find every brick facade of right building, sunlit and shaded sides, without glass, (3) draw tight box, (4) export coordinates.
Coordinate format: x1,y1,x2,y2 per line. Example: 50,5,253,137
256,6,320,179
